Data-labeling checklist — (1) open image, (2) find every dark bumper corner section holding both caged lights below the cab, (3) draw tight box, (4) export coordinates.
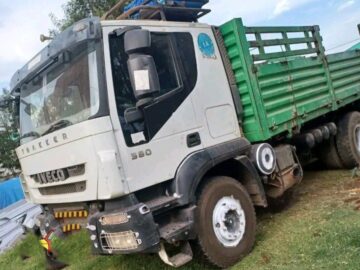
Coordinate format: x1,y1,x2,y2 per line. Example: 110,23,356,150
88,203,160,254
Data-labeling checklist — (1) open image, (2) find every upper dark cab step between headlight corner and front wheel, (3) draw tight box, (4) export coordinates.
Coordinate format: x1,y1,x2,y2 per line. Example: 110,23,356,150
160,221,194,243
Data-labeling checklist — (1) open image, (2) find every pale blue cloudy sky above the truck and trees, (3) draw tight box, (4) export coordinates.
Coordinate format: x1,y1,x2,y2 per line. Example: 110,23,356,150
0,0,360,89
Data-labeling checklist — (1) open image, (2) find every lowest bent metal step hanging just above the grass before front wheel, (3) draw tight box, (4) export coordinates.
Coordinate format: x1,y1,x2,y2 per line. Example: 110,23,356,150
159,241,193,268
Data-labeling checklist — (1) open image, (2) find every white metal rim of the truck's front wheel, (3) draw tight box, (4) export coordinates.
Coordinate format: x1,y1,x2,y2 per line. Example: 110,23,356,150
213,196,246,247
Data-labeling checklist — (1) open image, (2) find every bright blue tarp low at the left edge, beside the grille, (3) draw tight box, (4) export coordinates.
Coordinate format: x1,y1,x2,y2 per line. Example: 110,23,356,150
0,178,24,209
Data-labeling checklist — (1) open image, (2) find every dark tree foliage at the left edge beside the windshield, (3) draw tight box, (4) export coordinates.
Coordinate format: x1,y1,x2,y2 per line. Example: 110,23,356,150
0,89,20,177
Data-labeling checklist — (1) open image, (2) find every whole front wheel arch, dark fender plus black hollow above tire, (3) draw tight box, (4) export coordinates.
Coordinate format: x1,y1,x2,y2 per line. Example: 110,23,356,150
172,138,268,207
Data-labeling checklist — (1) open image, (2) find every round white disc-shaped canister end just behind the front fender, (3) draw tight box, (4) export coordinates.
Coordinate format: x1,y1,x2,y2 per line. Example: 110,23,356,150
252,143,276,175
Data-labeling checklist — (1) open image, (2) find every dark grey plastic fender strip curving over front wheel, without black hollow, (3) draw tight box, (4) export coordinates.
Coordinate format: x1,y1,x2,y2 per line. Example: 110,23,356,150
171,138,265,205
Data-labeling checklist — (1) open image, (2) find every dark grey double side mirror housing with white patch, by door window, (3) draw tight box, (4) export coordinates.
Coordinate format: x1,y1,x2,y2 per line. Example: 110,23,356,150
124,29,160,107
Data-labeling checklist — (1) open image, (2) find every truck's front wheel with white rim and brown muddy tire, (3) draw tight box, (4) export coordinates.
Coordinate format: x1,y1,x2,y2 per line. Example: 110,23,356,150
196,176,256,268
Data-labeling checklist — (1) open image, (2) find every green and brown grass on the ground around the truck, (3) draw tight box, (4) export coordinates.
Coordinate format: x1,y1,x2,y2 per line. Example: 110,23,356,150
0,171,360,270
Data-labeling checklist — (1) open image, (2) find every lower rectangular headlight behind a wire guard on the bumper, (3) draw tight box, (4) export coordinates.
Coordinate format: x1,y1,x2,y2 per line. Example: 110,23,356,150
101,231,141,251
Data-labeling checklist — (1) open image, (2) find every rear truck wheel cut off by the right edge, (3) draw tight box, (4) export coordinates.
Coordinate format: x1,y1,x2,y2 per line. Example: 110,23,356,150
336,112,360,169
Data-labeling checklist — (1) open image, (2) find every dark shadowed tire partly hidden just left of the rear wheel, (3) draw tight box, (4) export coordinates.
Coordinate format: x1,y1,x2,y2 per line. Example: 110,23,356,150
318,136,345,170
